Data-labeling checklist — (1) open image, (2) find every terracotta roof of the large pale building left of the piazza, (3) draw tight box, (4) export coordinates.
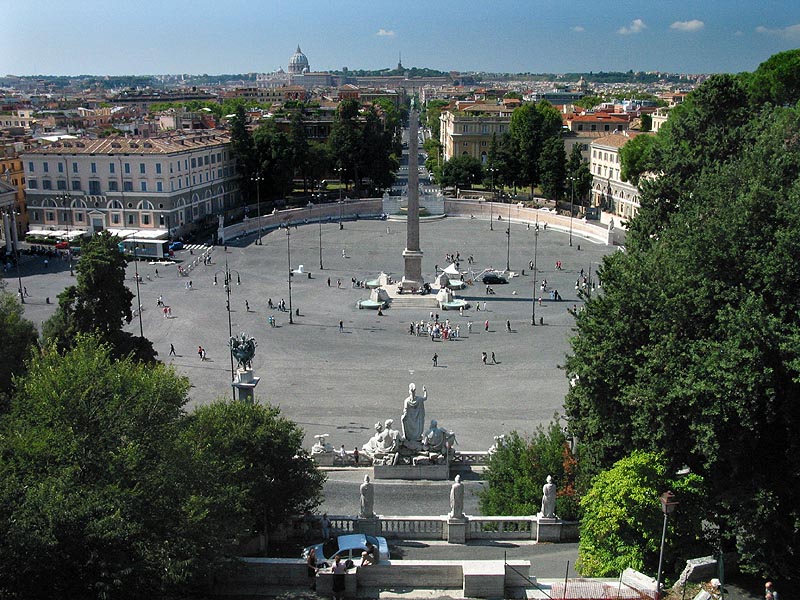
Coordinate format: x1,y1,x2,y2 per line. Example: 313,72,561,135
30,131,230,154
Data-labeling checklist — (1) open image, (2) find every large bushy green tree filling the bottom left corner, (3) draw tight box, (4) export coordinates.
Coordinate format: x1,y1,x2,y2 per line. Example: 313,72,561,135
0,336,197,598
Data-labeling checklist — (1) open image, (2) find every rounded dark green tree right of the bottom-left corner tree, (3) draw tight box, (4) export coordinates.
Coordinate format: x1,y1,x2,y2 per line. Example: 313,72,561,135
181,400,325,537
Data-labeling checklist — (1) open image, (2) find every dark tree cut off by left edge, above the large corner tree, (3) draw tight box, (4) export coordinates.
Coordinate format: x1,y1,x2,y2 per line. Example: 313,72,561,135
0,281,39,414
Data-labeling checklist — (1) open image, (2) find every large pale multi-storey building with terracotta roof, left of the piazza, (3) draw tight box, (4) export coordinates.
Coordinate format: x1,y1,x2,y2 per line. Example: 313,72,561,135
20,131,239,237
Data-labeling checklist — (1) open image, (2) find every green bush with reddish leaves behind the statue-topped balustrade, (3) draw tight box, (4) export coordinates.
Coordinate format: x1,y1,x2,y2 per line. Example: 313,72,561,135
480,416,578,520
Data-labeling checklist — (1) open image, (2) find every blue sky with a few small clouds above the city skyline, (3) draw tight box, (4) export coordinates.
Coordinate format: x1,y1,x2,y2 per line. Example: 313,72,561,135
0,0,800,75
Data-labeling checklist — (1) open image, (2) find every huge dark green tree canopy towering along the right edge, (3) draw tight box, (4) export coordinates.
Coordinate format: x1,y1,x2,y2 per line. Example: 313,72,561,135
565,58,800,577
